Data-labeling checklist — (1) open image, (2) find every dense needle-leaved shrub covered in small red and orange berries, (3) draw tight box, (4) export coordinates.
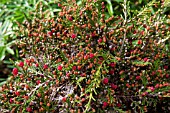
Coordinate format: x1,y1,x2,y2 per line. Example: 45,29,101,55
0,0,170,113
